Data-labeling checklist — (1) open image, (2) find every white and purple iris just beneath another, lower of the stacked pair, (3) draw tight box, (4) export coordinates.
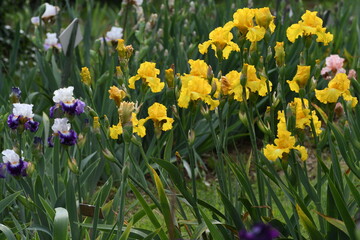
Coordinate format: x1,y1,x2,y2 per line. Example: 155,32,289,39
48,118,77,147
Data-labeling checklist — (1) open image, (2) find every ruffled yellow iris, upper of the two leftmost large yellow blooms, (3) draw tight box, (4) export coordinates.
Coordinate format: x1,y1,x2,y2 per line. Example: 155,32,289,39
129,62,165,93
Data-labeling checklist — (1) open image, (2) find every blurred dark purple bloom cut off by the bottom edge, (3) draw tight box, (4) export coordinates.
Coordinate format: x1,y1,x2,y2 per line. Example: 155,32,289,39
239,223,280,240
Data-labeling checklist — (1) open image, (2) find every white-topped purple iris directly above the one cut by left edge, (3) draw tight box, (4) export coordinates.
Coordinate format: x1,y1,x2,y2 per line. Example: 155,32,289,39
7,103,39,132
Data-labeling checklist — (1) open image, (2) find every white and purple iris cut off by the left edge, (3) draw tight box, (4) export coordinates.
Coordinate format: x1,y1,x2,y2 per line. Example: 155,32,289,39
0,149,28,178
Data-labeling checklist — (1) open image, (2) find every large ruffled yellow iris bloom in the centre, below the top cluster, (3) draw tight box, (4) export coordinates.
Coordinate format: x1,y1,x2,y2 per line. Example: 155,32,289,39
178,60,220,110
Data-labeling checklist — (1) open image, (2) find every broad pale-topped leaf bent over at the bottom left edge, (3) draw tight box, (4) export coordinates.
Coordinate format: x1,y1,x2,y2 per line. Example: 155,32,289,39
53,207,69,240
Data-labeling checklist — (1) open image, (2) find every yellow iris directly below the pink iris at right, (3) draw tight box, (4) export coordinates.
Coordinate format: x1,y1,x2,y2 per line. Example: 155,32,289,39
315,73,358,107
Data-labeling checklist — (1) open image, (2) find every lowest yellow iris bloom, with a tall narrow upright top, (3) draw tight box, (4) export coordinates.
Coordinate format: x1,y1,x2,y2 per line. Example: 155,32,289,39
264,111,308,161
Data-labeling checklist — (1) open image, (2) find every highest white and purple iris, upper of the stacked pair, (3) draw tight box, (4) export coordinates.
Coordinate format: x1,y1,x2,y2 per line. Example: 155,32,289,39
50,86,85,118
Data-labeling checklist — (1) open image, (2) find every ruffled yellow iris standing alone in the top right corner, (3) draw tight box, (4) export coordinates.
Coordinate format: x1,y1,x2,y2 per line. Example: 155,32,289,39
286,10,334,45
